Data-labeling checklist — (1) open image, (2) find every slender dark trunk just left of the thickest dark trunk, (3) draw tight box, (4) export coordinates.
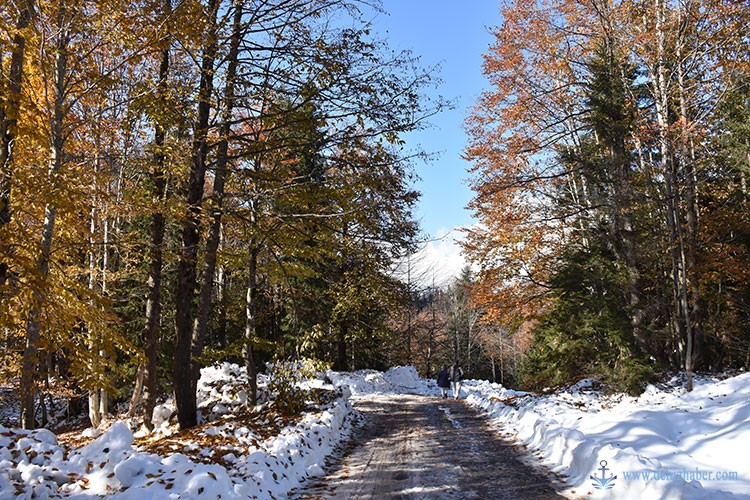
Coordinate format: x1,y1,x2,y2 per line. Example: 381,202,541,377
141,0,172,430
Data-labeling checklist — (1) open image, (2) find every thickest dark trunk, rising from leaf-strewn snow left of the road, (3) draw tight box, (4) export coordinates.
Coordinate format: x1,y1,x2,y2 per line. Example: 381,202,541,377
172,0,221,429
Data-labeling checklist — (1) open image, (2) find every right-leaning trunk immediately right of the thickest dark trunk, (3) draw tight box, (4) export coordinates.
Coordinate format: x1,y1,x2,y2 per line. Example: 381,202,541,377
192,0,242,383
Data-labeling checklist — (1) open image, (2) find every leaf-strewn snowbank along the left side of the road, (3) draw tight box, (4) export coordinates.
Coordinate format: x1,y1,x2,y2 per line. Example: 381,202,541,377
0,364,352,500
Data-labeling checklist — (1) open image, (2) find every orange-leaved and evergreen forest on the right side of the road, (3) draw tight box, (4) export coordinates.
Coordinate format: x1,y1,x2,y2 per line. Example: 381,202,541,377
465,0,750,393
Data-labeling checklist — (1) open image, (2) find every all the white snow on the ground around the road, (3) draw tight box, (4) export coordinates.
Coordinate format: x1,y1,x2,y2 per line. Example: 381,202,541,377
0,363,750,500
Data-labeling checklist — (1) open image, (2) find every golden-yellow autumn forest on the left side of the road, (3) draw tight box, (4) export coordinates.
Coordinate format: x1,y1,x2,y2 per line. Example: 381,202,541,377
0,0,444,428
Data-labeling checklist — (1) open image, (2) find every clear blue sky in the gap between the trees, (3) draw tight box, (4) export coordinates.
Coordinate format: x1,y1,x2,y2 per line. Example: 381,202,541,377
374,0,500,236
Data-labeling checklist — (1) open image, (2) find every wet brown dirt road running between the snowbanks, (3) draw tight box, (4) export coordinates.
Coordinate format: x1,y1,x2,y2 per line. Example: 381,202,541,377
290,395,559,500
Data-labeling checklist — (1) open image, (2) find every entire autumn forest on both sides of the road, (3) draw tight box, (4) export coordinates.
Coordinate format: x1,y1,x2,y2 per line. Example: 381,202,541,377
0,0,750,429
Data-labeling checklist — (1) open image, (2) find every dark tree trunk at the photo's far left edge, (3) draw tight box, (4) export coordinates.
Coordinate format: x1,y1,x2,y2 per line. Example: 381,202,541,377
0,2,34,290
